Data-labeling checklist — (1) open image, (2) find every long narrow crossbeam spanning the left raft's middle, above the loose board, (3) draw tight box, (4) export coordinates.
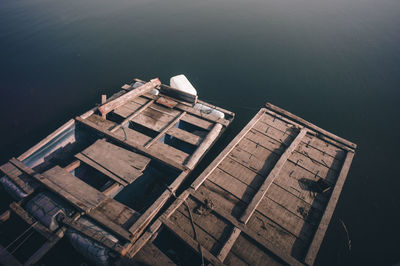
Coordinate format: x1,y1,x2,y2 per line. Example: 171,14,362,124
76,116,187,171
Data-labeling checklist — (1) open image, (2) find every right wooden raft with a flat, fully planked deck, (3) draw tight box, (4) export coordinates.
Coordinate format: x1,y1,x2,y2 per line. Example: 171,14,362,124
130,104,356,265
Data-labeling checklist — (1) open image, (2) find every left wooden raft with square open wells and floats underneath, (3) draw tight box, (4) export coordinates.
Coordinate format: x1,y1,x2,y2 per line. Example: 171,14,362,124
0,79,234,265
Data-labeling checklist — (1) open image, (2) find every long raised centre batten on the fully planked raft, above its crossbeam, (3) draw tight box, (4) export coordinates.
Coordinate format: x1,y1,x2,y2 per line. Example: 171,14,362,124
240,128,308,223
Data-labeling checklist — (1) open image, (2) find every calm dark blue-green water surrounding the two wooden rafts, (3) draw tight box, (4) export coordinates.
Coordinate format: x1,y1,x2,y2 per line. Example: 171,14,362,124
0,0,400,265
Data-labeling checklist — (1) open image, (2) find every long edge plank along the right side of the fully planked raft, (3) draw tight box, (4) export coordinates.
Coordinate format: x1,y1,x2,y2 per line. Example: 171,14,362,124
305,152,354,265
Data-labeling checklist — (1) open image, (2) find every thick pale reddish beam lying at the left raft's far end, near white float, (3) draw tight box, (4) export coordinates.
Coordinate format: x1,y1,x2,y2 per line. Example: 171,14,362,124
98,79,161,115
